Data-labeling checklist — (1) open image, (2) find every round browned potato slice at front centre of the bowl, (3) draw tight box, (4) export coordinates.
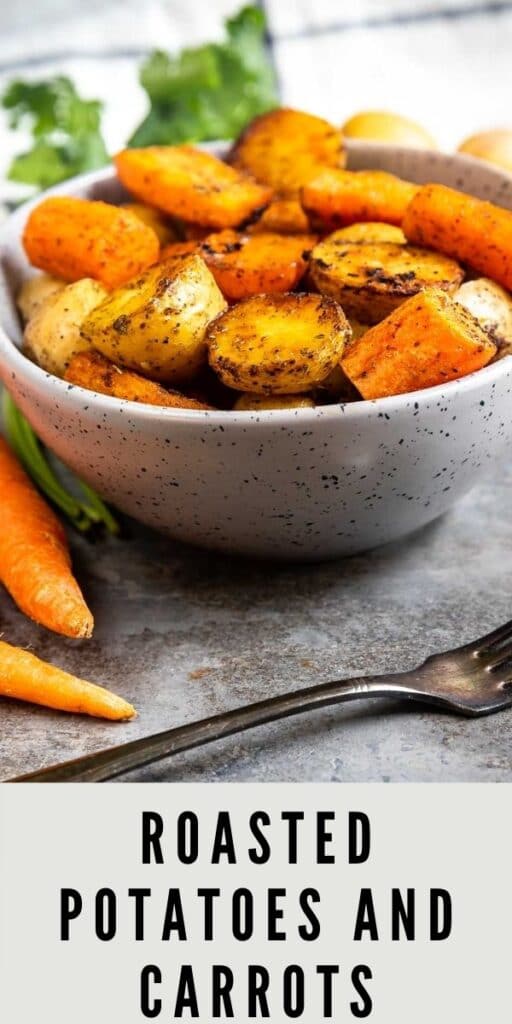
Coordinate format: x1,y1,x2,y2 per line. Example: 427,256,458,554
207,294,350,394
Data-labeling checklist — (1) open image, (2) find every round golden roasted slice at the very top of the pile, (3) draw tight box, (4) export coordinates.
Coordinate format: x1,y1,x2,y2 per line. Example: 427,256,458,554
229,108,344,199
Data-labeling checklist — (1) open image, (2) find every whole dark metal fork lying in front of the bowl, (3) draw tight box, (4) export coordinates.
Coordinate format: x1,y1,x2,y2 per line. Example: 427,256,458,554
10,621,512,782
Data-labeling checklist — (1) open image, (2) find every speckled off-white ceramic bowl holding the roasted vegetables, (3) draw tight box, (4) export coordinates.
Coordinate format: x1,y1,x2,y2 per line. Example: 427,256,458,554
0,142,512,560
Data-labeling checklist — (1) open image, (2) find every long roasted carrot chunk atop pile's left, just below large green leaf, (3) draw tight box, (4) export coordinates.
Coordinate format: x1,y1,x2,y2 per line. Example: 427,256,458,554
115,145,271,227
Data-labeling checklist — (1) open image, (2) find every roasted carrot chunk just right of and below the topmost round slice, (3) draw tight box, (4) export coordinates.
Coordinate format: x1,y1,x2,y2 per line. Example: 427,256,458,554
302,169,418,228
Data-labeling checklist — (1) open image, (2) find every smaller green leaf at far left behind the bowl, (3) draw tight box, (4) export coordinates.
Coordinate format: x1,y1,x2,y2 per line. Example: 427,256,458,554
2,76,109,188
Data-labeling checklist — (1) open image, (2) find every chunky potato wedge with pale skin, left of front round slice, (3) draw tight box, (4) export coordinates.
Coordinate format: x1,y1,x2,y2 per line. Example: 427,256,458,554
82,254,226,384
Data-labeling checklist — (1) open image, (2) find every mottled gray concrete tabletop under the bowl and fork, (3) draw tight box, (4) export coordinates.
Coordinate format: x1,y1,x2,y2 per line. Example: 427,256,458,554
0,468,512,782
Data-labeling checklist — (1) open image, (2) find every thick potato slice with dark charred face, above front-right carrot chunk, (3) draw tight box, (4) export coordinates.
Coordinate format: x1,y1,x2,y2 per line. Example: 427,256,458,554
309,231,464,324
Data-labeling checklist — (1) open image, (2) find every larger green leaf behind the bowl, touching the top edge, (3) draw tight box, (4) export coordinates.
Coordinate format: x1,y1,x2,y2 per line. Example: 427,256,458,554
129,6,278,146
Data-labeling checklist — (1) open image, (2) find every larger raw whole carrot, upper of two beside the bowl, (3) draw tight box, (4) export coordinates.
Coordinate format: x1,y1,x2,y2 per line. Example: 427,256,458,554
0,438,94,638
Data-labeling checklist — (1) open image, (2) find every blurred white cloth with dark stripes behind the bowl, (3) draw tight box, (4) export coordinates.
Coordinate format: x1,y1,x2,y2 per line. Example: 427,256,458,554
0,0,512,200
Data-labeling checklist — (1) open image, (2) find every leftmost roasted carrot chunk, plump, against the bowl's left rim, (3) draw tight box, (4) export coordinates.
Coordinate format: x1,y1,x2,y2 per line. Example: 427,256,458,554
24,196,160,288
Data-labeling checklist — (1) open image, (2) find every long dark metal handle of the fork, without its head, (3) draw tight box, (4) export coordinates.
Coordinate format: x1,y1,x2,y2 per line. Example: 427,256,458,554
9,673,426,782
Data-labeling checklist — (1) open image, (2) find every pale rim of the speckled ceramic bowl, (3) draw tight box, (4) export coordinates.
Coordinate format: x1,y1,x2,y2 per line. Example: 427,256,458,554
0,148,512,427
